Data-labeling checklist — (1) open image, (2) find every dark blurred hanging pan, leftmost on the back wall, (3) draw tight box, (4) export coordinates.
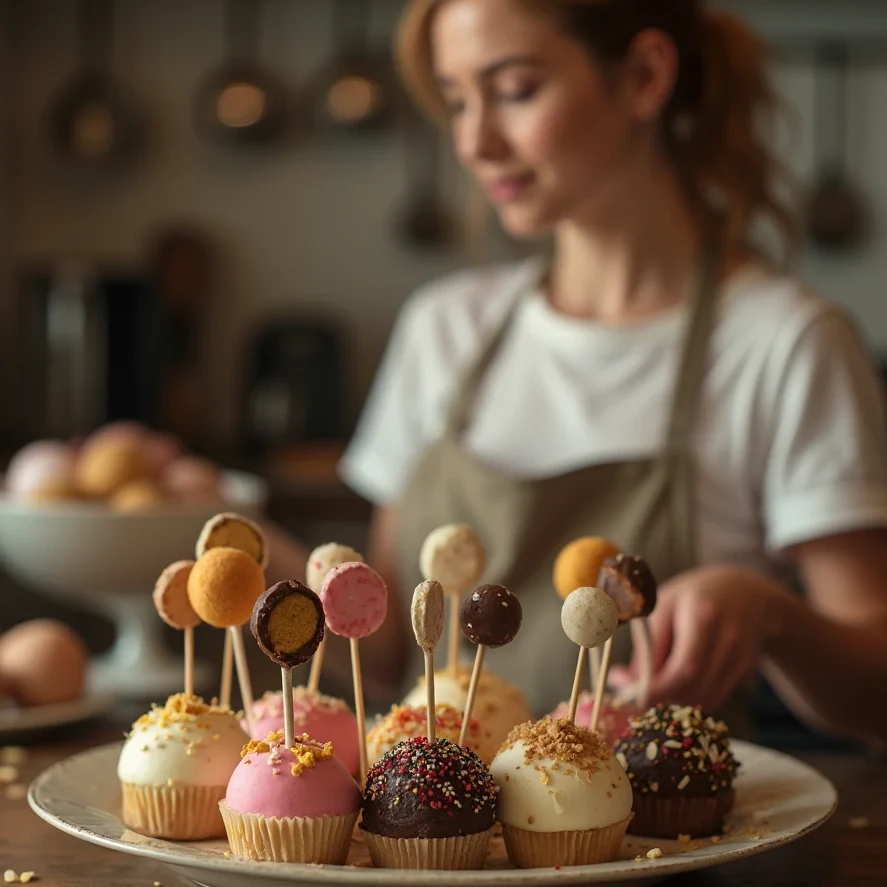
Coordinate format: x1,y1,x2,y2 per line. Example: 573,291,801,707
49,0,141,169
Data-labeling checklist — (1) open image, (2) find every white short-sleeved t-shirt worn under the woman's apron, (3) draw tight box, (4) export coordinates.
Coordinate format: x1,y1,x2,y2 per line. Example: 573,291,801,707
340,261,887,569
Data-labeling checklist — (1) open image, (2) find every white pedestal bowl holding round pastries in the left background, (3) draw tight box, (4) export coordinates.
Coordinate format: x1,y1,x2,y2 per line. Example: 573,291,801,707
0,472,268,699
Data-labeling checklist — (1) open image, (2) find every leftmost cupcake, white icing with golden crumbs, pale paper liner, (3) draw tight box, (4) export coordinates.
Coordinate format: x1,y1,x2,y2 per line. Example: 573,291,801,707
117,693,249,841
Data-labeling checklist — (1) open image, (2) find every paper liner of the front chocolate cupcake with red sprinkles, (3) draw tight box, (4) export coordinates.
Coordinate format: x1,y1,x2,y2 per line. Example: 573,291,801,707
363,829,493,871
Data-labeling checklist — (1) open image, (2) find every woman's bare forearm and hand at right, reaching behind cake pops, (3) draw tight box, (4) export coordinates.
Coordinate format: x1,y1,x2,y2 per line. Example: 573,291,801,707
614,530,887,743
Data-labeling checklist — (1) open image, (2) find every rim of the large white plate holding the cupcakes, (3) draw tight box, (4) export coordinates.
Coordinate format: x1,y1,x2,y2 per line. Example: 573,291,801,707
28,740,839,887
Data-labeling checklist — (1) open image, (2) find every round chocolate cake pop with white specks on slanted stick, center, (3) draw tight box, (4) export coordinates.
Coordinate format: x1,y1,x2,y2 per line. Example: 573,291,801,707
459,585,523,745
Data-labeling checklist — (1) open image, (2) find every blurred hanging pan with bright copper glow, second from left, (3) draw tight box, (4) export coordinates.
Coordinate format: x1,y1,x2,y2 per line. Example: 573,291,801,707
197,0,285,145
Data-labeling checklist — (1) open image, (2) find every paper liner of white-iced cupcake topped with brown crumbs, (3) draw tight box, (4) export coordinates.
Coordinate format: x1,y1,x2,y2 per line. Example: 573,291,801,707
502,816,631,869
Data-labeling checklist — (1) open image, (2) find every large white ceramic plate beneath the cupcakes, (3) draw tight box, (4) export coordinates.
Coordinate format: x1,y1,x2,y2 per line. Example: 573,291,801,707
28,742,837,887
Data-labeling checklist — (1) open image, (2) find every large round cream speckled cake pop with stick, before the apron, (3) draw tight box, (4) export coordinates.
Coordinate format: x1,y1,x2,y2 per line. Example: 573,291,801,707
419,524,487,674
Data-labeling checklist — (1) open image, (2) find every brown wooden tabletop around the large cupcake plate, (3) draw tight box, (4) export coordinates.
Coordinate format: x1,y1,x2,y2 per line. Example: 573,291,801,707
0,725,887,887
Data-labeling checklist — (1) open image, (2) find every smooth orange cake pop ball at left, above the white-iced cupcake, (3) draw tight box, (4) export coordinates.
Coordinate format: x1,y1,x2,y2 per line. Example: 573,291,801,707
188,548,265,628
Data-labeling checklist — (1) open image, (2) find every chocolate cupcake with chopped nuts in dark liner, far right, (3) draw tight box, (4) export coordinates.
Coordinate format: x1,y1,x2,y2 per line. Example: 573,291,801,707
615,705,739,838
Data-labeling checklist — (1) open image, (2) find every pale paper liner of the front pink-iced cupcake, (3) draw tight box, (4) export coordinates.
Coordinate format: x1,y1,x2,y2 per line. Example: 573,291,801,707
218,801,357,865
